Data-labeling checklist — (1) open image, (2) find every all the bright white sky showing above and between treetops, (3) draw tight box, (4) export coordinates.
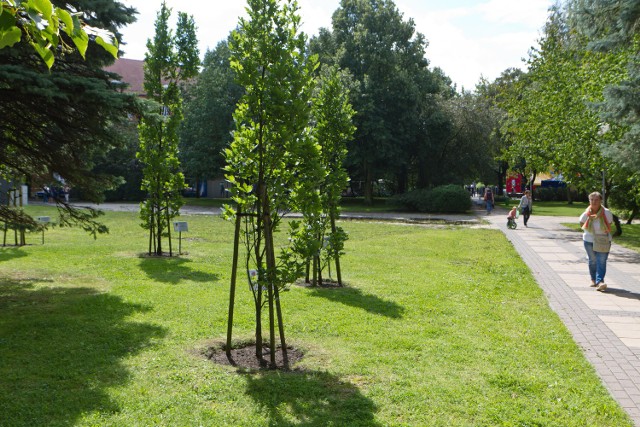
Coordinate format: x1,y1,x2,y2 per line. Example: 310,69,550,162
120,0,555,90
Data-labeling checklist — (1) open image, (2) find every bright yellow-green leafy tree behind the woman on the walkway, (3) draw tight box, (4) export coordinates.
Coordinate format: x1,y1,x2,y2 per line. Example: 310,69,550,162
504,3,633,232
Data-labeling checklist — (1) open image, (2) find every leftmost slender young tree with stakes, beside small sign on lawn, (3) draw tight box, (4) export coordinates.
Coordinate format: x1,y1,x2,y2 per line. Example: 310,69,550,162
137,2,199,255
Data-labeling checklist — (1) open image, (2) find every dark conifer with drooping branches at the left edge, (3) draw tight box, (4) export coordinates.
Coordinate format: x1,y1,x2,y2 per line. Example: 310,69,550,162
0,1,138,235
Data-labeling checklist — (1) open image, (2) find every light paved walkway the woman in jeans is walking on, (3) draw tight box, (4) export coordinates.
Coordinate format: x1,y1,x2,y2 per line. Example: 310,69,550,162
478,206,640,427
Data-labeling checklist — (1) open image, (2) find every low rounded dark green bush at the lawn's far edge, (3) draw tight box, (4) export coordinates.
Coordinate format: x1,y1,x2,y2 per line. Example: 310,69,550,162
393,184,471,213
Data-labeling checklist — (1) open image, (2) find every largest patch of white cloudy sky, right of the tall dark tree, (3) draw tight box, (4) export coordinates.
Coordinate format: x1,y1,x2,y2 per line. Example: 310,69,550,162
396,0,552,90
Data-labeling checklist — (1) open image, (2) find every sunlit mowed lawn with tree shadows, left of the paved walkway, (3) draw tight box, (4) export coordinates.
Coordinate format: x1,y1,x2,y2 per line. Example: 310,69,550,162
0,207,632,427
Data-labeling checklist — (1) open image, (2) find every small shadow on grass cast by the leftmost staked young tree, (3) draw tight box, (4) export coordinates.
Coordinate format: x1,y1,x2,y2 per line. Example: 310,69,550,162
140,257,219,284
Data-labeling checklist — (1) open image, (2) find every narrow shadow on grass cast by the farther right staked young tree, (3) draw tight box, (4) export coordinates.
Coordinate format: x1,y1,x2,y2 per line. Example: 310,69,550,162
311,287,404,319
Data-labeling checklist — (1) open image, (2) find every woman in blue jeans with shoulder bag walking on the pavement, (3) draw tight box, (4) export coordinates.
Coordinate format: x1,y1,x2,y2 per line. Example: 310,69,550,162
580,191,613,292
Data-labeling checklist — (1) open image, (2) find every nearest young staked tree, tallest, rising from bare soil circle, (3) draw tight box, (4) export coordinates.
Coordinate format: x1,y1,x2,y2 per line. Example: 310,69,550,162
225,0,320,368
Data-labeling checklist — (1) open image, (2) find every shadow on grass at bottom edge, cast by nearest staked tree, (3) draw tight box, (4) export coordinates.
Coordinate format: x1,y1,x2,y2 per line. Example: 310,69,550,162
246,371,381,427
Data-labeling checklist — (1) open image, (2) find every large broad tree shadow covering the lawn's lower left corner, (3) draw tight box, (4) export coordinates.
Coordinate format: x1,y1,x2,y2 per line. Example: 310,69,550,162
0,279,165,426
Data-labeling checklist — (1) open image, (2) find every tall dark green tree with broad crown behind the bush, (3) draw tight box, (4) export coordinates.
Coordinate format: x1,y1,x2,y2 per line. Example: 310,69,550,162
313,0,440,201
